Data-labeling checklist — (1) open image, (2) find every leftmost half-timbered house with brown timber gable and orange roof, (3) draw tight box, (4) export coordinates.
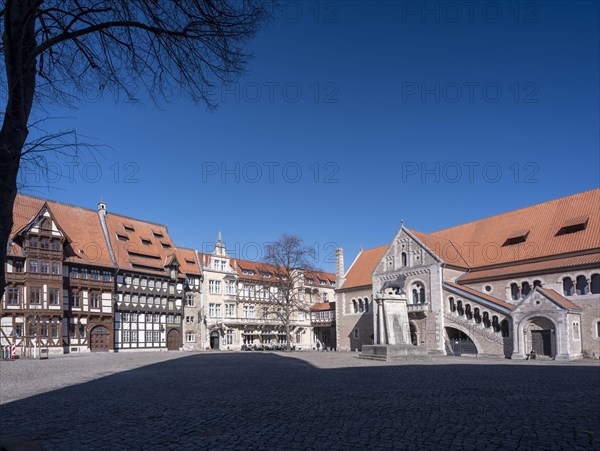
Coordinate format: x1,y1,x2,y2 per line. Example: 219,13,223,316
0,194,115,355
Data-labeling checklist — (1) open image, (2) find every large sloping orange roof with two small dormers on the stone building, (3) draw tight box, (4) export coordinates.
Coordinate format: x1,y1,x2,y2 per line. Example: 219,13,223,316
429,188,600,268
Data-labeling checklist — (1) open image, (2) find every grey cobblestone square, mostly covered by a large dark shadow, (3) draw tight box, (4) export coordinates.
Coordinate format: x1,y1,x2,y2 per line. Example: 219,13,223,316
0,352,600,450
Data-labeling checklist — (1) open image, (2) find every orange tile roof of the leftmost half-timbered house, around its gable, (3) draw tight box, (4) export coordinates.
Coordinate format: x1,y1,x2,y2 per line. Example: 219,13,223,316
11,193,114,268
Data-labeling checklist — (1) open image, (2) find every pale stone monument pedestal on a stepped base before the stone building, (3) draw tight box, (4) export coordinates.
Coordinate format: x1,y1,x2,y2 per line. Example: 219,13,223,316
359,293,429,362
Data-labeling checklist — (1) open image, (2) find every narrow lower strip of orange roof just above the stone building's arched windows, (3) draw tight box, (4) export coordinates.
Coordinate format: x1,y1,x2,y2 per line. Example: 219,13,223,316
458,252,600,283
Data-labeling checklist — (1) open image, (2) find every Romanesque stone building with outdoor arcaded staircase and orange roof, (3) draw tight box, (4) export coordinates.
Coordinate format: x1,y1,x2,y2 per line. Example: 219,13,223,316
336,189,600,359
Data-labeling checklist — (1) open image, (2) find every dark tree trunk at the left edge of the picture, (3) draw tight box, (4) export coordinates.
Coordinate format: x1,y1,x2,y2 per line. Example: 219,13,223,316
0,0,37,298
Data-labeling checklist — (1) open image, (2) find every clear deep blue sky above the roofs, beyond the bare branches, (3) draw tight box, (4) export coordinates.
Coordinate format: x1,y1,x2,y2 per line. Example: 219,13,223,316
21,1,600,271
